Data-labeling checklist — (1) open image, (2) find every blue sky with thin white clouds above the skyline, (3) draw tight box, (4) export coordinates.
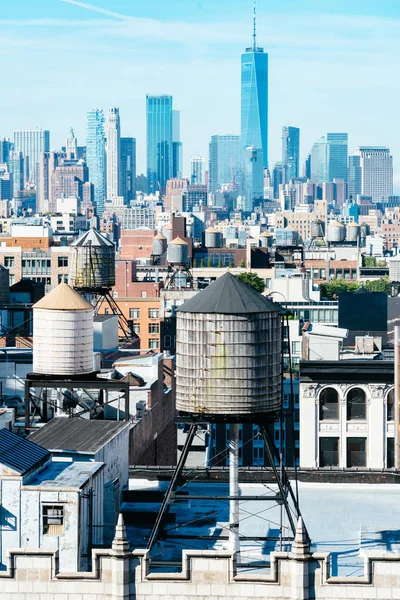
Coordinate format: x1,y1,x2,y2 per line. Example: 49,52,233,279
0,0,400,192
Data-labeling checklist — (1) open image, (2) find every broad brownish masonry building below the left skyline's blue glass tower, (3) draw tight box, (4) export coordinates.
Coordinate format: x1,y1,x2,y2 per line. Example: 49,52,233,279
51,159,89,204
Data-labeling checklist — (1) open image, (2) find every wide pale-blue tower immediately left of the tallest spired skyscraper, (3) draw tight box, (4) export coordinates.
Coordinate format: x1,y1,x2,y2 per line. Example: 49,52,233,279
208,135,242,194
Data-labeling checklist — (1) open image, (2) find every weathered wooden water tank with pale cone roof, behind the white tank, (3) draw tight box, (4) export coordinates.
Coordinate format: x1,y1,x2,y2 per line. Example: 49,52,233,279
69,229,115,289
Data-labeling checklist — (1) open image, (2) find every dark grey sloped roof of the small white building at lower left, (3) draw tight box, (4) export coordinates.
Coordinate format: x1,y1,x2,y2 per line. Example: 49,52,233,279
29,417,128,454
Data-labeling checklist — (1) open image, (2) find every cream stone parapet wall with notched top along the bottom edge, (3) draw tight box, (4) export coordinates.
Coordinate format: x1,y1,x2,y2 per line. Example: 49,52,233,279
0,544,400,600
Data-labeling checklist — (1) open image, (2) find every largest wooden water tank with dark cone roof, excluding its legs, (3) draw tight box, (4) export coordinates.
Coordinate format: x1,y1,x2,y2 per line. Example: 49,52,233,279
176,273,282,422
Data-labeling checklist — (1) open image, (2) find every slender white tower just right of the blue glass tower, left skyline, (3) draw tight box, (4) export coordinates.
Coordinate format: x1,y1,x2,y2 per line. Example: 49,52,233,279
106,106,121,199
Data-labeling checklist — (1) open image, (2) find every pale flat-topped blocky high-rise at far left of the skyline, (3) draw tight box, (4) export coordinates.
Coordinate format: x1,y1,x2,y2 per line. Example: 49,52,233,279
14,129,50,185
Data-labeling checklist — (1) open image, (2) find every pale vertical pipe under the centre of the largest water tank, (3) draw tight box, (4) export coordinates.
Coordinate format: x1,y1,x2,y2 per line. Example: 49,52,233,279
229,423,240,552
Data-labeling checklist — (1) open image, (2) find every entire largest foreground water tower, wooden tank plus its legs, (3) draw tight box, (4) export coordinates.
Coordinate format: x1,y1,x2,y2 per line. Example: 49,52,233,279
147,272,299,553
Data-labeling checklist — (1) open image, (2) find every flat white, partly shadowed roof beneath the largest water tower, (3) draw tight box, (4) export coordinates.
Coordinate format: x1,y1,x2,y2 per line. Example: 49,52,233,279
122,480,400,576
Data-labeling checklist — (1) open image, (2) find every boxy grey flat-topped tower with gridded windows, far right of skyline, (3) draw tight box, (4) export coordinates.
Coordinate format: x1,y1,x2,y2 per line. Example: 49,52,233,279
356,146,393,202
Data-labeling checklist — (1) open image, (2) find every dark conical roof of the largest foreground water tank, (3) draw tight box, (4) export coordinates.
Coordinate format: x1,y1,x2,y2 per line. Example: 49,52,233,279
177,273,280,315
